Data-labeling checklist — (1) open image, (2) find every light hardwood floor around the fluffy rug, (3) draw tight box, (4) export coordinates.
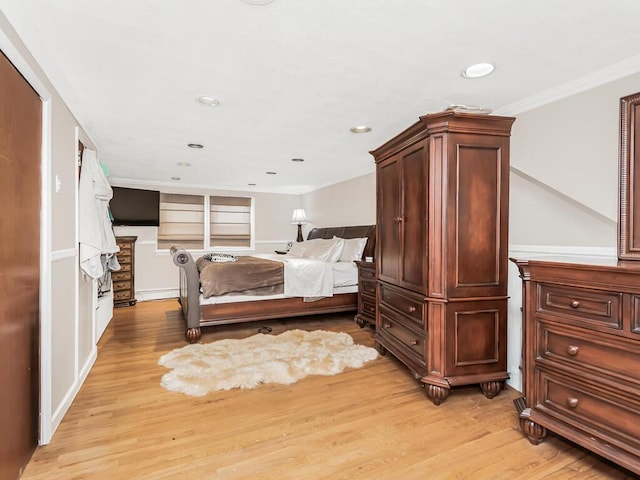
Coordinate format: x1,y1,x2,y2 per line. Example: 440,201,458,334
22,300,635,480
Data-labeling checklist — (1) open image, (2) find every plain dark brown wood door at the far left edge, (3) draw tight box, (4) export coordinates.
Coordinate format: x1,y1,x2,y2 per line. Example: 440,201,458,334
0,48,42,480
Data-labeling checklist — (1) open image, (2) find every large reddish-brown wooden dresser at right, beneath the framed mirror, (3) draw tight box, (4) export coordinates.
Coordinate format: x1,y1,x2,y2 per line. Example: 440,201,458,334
512,258,640,475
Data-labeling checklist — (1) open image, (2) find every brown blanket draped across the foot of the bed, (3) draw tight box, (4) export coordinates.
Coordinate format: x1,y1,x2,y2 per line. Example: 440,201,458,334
196,255,284,298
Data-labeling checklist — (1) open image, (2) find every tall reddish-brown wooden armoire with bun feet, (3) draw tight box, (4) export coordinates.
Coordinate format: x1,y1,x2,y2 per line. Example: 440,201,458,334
370,111,514,405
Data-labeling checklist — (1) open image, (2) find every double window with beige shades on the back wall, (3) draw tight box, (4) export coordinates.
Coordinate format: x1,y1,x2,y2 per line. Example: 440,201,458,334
158,193,253,250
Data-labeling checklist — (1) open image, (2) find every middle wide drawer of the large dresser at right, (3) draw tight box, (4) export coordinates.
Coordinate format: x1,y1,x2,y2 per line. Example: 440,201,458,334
536,320,640,384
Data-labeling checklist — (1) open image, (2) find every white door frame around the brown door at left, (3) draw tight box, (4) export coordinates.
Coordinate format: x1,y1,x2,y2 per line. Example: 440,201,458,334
0,19,54,445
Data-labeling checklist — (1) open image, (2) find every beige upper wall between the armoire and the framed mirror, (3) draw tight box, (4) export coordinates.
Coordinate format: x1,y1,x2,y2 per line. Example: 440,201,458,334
509,70,640,247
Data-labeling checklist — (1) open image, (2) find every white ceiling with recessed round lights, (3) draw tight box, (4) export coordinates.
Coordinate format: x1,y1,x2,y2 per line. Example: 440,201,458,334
0,0,640,193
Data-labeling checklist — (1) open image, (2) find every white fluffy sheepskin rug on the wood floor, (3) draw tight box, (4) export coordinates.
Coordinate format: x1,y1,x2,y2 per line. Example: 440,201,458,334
158,330,378,397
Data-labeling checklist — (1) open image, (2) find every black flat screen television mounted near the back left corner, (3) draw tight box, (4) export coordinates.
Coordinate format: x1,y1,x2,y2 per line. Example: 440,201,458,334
109,187,160,227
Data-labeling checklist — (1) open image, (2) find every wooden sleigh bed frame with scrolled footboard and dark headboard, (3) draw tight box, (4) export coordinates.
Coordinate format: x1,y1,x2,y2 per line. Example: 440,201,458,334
171,225,375,343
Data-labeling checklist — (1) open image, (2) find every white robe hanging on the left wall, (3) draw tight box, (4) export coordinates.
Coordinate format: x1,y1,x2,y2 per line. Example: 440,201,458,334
78,149,120,278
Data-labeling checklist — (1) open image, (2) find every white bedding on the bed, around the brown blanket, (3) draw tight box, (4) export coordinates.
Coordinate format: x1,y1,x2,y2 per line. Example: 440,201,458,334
200,253,358,304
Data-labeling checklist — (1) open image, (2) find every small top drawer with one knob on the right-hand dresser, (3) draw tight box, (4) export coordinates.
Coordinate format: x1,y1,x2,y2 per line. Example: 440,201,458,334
536,283,622,329
